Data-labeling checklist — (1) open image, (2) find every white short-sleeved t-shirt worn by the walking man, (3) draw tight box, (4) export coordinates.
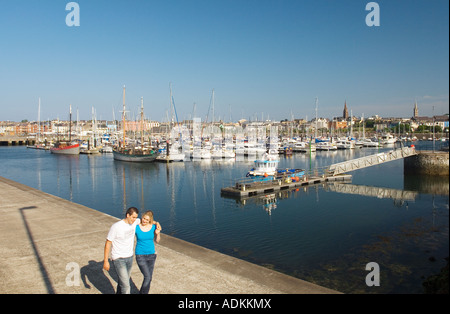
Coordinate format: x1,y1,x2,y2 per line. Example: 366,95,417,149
106,218,141,260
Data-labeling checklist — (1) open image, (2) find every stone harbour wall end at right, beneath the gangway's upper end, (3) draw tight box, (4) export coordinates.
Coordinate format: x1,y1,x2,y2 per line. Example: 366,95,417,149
403,151,449,176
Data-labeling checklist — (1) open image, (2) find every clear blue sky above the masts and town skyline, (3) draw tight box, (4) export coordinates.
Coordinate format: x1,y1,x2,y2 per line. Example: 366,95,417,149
0,0,449,121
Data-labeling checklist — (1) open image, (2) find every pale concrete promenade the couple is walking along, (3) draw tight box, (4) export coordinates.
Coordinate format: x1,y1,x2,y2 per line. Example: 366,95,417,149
0,177,337,294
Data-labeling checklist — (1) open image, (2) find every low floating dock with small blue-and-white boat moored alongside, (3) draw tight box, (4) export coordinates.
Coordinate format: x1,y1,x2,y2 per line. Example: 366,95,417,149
220,174,352,198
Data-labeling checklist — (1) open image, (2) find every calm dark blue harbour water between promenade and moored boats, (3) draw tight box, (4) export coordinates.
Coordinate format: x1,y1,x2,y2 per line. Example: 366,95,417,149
0,143,449,293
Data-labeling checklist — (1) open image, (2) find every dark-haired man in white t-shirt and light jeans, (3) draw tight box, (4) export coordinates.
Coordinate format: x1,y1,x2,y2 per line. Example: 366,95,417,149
103,207,140,294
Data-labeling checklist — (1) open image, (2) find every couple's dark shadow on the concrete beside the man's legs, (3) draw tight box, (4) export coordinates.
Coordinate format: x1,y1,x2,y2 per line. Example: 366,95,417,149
80,260,139,294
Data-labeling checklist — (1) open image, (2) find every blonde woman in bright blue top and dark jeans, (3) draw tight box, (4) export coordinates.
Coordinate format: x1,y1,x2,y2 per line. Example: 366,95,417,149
135,211,161,294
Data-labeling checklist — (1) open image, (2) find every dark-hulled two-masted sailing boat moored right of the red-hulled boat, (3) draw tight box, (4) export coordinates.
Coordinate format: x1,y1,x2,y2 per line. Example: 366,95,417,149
113,86,159,162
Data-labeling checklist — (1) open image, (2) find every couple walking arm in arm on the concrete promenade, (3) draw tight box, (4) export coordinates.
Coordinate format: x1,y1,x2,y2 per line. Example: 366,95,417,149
103,207,161,294
